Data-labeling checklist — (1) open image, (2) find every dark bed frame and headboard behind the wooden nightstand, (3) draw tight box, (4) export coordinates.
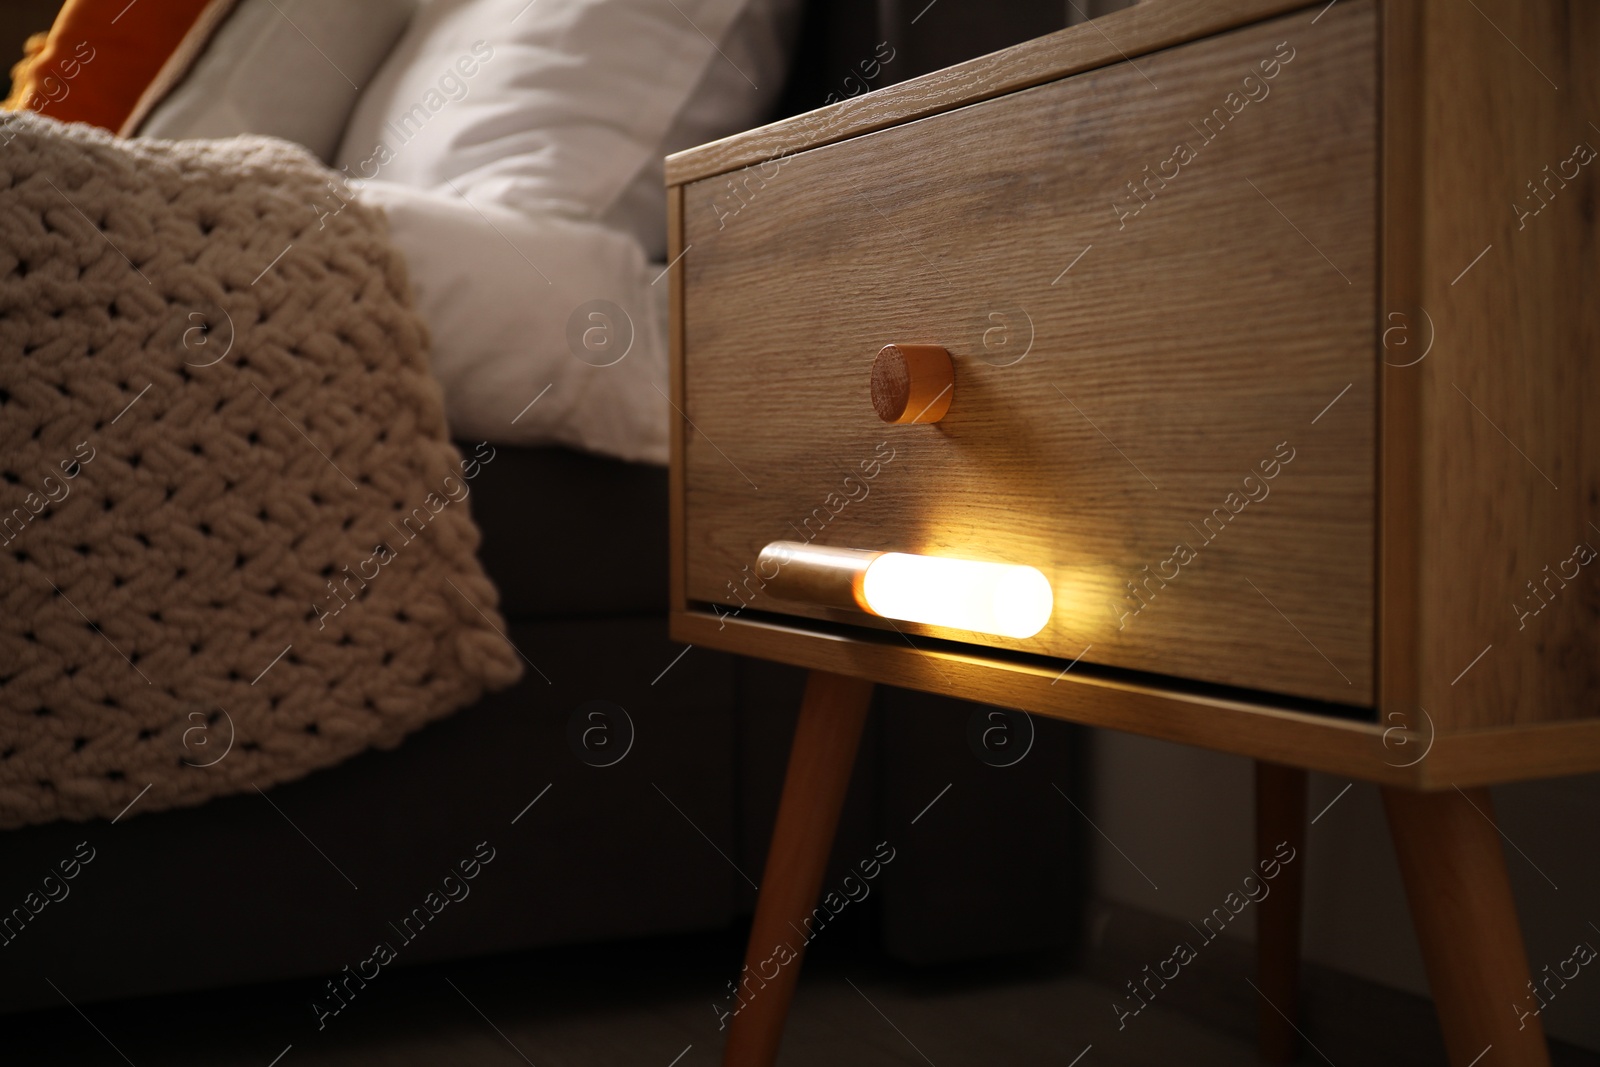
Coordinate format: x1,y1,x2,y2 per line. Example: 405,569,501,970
0,0,1104,1011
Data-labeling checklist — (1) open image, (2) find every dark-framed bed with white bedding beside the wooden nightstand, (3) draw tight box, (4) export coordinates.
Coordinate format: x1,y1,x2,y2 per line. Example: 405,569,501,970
0,0,1094,1009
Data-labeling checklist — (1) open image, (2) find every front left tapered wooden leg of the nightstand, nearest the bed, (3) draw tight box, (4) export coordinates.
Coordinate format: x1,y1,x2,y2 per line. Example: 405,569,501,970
722,670,872,1067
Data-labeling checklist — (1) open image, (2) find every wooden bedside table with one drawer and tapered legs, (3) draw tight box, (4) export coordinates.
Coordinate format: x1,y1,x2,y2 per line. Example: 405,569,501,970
667,0,1600,1067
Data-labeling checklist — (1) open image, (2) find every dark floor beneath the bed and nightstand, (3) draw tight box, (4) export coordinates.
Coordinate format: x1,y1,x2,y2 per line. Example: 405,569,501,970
12,931,1600,1067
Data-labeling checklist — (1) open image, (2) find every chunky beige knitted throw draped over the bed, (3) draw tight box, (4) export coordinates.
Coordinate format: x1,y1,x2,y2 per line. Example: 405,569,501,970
0,114,522,827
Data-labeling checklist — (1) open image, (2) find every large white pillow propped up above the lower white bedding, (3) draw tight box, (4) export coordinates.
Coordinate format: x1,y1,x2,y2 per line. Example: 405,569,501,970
336,0,782,228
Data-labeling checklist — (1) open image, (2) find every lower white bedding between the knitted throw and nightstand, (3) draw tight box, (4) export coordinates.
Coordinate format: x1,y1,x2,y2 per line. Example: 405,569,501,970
357,181,669,464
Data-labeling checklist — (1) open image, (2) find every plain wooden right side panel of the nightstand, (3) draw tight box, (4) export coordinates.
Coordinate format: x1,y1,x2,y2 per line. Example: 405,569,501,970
1414,0,1600,729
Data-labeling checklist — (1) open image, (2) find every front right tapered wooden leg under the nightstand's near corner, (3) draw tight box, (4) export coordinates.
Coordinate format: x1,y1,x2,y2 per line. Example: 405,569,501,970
1384,789,1550,1067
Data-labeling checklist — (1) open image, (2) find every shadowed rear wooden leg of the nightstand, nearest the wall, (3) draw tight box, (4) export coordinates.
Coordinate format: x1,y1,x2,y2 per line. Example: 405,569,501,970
1256,761,1306,1064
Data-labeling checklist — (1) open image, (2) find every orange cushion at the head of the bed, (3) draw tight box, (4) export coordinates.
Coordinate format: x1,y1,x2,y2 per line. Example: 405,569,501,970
5,0,219,131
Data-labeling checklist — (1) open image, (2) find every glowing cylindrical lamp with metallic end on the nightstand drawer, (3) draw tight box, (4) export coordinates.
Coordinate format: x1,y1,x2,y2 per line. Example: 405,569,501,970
762,541,1054,637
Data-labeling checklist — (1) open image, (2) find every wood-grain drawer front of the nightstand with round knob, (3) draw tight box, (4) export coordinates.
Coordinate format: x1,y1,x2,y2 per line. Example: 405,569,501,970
680,2,1379,705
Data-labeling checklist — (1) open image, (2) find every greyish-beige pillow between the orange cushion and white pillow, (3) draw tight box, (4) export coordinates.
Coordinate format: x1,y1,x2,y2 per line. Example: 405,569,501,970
138,0,418,163
